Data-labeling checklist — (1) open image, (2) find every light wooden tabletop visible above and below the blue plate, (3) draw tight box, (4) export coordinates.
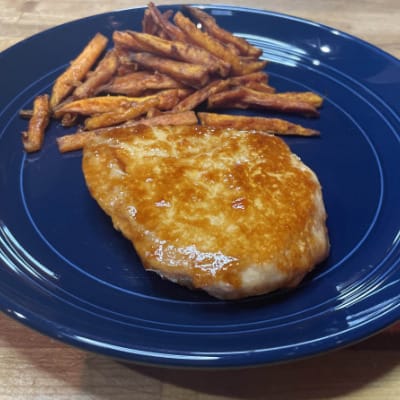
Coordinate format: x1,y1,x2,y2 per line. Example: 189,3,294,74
0,0,400,400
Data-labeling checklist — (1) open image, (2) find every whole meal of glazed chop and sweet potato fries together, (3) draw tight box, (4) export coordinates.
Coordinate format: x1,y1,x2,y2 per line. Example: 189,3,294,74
21,3,329,299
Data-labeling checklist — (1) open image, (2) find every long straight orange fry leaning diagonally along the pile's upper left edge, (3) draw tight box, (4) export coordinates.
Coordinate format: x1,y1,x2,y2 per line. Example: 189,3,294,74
50,33,108,110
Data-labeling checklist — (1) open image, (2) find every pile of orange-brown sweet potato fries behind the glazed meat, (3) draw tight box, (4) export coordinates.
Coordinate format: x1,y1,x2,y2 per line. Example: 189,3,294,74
21,3,323,152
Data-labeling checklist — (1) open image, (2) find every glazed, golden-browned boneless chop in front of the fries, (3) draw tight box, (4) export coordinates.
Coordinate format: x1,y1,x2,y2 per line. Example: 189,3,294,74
83,126,329,299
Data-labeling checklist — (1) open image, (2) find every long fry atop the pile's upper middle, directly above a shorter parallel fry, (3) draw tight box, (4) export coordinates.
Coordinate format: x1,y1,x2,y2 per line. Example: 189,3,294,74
128,31,231,77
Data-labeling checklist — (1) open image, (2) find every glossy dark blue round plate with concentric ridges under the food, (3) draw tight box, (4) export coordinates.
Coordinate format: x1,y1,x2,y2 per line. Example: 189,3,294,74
0,6,400,367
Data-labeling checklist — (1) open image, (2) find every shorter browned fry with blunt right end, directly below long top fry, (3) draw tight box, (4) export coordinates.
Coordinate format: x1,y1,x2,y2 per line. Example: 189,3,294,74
132,53,210,88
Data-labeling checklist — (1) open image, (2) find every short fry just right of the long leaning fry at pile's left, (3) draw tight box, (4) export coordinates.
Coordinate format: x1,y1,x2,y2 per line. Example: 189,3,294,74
72,50,118,99
